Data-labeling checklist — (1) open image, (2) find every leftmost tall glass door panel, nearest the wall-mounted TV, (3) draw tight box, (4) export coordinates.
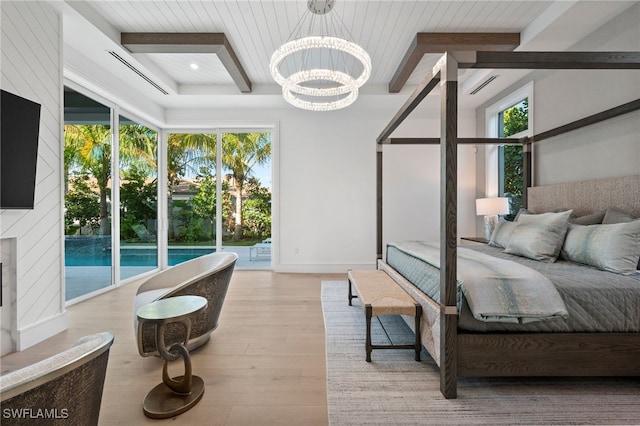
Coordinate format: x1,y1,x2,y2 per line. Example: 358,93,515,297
64,87,113,300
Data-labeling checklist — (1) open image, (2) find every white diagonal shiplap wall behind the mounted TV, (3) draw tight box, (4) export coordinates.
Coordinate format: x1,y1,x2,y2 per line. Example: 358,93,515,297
0,1,67,350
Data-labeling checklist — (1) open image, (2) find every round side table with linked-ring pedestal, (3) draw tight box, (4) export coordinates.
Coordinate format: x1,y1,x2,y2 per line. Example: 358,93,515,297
137,296,207,419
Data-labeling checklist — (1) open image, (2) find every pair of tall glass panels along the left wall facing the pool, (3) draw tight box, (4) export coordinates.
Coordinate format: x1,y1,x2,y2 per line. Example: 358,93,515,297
64,86,159,301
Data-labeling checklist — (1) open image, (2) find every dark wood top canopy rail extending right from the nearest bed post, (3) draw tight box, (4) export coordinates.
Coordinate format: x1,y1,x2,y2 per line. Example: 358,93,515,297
459,51,640,70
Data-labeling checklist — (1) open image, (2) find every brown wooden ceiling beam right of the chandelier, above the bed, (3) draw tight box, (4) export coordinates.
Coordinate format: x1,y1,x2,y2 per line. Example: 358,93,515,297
389,33,520,93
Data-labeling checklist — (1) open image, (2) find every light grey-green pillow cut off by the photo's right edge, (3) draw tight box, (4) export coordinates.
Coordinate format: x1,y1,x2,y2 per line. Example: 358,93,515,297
562,220,640,275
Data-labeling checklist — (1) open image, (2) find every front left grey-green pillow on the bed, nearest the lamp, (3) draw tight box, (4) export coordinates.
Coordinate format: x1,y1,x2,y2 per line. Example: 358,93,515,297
504,210,573,262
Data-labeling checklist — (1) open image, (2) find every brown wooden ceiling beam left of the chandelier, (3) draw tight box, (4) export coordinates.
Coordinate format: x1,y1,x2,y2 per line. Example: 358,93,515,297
120,33,251,93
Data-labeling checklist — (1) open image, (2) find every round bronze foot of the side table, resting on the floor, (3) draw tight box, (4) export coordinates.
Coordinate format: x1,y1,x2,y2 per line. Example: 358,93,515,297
143,376,204,419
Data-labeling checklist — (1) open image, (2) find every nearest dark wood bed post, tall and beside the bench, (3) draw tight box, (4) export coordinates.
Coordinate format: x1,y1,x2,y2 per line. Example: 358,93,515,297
439,53,458,399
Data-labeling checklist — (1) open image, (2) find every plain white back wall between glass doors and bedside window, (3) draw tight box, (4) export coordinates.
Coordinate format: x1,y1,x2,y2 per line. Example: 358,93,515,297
166,108,475,272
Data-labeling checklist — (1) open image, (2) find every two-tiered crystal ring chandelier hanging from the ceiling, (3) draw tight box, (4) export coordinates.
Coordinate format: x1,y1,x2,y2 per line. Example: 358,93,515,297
269,0,371,111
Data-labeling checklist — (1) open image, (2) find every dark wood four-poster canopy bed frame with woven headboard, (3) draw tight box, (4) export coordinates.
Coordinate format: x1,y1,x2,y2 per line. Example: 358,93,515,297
377,52,640,398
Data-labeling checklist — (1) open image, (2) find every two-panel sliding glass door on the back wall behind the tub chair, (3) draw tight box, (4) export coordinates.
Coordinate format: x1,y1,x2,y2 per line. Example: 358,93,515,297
167,130,271,268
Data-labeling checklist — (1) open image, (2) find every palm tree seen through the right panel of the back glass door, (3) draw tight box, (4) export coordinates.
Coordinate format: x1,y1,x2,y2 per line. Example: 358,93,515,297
222,133,271,241
